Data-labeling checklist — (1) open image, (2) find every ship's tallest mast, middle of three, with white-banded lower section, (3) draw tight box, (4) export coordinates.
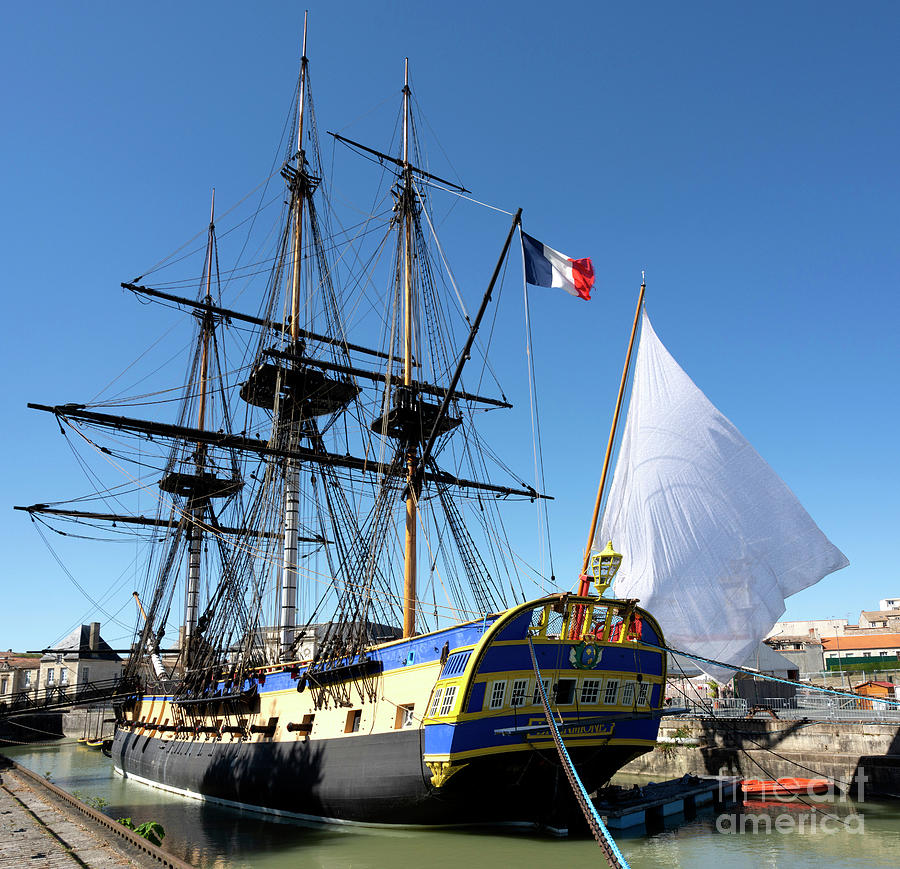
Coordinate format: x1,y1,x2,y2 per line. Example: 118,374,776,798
279,13,309,658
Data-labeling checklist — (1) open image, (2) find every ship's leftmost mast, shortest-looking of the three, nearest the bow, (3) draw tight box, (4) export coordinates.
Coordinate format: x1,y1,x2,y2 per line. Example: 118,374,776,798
182,188,216,648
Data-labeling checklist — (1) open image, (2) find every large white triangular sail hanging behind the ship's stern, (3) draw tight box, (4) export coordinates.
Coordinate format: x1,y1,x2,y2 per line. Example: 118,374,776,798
594,313,849,679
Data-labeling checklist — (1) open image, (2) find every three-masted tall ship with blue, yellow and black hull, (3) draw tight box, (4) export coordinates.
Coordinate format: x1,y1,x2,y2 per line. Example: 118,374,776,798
19,20,666,826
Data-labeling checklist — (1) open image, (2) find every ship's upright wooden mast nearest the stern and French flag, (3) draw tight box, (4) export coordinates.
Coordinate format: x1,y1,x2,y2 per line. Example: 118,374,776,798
402,58,419,637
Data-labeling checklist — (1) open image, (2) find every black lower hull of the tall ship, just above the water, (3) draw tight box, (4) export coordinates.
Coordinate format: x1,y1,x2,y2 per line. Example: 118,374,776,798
112,729,648,828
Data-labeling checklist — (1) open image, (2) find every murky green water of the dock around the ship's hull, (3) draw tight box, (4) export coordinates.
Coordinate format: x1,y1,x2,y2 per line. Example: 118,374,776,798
4,742,900,869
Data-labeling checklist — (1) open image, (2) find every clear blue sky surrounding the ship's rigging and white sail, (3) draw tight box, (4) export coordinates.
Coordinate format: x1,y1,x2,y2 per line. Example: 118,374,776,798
0,2,900,649
